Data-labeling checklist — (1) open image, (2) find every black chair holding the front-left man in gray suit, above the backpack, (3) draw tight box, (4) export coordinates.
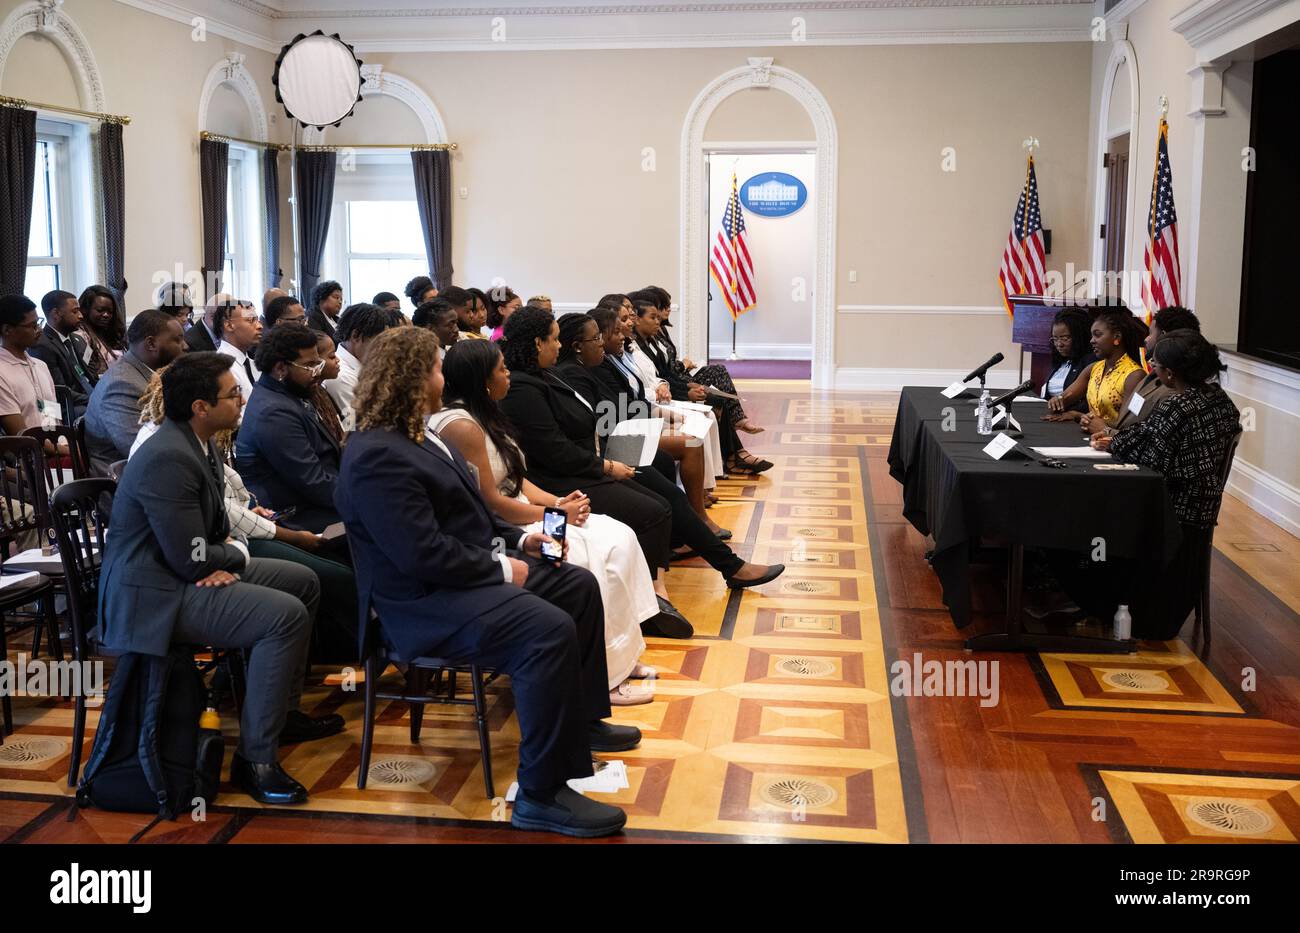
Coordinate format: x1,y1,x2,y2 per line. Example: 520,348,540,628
49,478,117,787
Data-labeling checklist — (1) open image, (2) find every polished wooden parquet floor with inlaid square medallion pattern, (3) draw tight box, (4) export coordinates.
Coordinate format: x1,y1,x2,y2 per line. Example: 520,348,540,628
0,381,1300,843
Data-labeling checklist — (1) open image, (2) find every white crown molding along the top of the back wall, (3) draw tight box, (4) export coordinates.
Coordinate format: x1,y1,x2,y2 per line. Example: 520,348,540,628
116,0,1092,53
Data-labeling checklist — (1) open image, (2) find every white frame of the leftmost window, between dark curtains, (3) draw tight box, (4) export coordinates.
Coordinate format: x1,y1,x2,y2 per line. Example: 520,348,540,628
27,113,100,306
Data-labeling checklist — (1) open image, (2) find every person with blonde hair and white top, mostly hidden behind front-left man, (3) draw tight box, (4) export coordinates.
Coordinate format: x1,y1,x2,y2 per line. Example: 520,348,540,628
131,366,358,664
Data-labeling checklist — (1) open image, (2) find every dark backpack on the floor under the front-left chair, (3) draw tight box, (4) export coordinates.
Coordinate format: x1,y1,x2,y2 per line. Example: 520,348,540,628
77,651,225,833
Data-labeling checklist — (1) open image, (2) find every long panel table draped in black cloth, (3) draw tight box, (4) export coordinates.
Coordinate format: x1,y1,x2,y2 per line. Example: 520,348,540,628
889,386,1180,651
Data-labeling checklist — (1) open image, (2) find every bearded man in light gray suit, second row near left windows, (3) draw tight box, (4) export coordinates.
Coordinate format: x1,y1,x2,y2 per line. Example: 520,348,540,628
86,308,186,476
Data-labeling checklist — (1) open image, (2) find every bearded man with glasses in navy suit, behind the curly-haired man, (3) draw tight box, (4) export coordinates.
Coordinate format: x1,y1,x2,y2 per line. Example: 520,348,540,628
235,324,341,533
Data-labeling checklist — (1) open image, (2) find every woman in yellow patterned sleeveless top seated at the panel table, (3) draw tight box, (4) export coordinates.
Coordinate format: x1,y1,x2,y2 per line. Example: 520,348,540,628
1044,308,1143,433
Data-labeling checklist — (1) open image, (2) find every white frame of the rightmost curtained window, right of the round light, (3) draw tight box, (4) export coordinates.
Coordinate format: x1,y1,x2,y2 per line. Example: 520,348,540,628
322,151,428,306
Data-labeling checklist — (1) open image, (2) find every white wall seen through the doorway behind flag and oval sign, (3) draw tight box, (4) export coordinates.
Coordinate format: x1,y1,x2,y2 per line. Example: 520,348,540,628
709,151,816,360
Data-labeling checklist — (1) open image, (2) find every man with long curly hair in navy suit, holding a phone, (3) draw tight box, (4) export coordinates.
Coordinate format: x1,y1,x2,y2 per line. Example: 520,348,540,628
335,327,641,836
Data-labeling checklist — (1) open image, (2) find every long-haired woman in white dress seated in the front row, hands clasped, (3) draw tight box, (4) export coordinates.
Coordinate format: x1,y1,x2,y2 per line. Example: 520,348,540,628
429,340,663,706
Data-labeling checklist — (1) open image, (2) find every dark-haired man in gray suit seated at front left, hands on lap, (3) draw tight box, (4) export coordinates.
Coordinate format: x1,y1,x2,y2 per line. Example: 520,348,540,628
99,353,343,803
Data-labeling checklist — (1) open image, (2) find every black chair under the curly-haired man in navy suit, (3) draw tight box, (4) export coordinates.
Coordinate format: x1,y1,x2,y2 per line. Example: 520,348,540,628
356,612,497,799
